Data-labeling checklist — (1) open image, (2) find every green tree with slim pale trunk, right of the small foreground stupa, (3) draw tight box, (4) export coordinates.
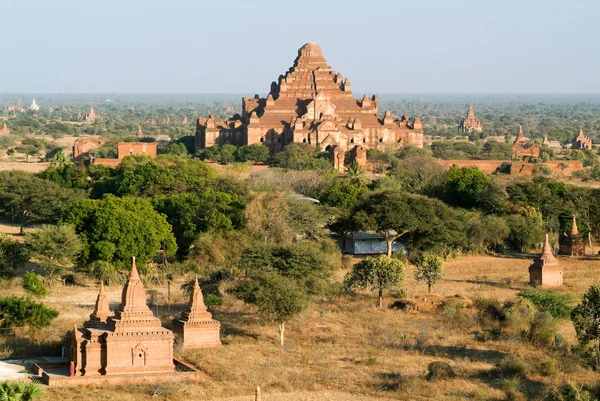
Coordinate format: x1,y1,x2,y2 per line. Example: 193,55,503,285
231,272,309,346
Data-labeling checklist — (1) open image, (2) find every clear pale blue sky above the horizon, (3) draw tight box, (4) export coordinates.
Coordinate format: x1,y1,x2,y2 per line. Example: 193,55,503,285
0,0,600,95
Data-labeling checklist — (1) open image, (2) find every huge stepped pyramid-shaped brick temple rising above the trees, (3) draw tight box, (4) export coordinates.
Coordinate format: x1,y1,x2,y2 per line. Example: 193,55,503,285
196,43,423,153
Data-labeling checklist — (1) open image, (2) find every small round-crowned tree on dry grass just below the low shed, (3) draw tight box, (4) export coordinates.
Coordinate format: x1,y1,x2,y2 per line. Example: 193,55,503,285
344,255,405,308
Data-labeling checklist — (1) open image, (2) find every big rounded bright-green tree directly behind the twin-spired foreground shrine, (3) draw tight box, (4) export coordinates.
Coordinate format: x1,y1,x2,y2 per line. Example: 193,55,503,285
62,195,177,267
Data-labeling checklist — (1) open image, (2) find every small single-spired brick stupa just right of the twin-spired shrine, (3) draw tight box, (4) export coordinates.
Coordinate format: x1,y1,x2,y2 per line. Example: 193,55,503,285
173,277,221,349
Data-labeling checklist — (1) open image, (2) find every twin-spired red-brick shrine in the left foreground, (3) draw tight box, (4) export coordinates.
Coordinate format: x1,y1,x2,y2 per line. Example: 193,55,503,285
68,258,175,376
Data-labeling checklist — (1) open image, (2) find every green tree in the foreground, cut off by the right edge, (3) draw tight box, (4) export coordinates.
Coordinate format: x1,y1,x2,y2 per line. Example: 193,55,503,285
571,284,600,370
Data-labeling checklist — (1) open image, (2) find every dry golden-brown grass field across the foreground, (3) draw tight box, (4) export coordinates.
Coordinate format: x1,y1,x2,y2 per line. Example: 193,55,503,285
0,256,600,401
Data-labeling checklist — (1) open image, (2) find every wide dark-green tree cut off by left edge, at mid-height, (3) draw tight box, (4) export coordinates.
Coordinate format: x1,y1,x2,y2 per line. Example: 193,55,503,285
0,171,85,231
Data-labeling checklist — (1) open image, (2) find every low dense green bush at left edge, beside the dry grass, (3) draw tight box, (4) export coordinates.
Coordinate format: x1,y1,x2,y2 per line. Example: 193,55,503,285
0,295,58,329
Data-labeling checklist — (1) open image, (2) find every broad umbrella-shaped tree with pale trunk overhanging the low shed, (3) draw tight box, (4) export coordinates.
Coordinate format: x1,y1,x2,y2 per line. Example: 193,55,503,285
331,190,466,257
